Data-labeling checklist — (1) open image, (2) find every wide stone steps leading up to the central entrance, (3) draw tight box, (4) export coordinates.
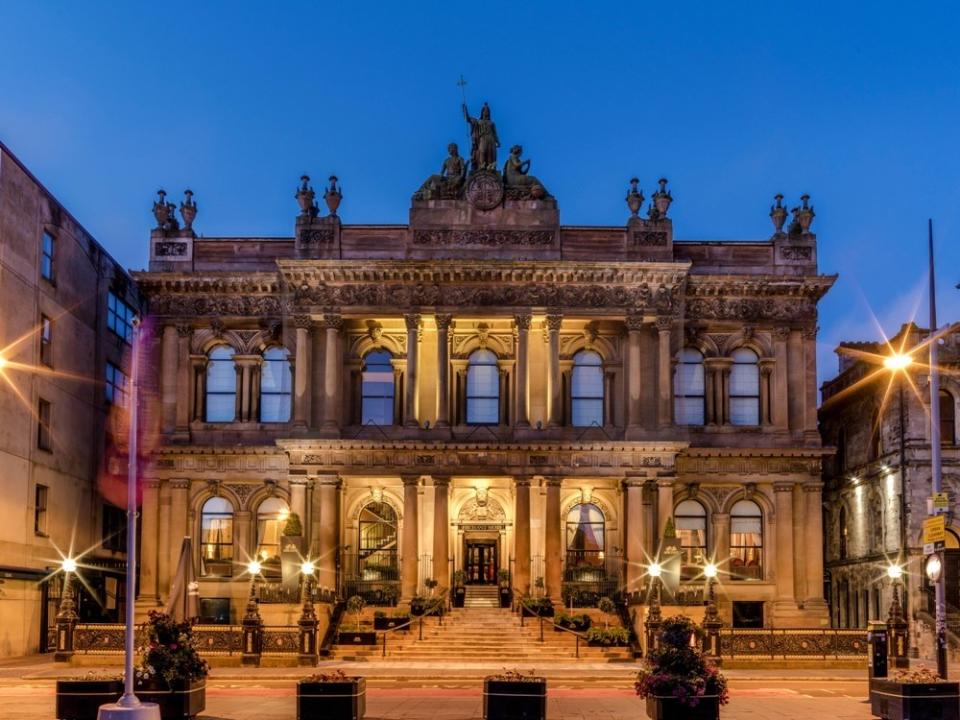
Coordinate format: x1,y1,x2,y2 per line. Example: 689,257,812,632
334,608,633,667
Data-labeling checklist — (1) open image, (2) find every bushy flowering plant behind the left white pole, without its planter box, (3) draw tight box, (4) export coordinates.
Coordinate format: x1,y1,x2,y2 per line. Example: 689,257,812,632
137,610,209,686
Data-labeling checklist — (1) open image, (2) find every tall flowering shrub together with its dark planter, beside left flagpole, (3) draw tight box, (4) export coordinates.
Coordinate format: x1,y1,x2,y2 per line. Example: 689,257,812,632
136,610,209,720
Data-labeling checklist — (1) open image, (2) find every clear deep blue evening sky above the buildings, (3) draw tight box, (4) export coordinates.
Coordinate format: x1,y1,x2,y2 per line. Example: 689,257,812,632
0,0,960,390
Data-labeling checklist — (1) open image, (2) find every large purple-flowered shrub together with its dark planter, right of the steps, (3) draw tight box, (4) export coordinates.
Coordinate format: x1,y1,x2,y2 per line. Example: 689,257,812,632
635,615,729,720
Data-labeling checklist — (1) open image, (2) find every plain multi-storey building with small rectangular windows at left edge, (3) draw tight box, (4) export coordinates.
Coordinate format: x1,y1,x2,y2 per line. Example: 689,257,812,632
0,144,139,657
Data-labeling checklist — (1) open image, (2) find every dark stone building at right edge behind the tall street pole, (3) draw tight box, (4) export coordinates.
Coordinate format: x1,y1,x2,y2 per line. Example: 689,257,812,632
820,323,960,649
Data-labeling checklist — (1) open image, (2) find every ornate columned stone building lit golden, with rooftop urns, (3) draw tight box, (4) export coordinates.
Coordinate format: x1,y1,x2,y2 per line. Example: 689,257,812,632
135,113,834,626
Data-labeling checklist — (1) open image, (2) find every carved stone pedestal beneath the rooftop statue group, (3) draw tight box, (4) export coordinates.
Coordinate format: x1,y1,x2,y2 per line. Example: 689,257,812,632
407,198,560,260
